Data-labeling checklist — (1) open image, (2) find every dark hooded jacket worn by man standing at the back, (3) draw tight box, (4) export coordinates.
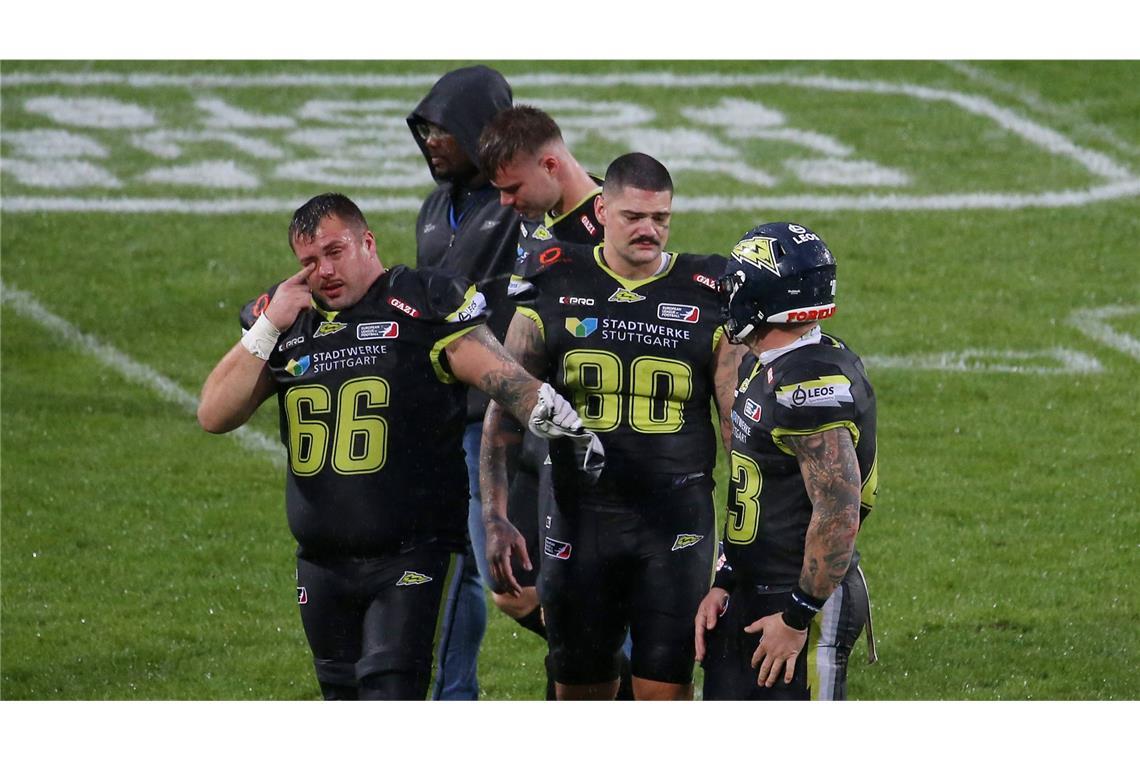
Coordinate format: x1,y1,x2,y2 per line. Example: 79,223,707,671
407,66,520,422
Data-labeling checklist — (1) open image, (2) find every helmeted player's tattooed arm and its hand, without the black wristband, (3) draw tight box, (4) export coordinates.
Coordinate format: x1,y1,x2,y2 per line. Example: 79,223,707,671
744,427,860,686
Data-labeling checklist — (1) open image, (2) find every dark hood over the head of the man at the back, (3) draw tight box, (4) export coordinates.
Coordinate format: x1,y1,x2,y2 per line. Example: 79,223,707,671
407,66,512,181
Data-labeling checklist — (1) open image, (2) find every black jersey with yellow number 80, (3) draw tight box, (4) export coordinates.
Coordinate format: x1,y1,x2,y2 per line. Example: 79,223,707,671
512,245,724,507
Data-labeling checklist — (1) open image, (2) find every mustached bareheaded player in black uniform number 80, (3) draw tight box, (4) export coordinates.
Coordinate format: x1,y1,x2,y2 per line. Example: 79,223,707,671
480,153,740,698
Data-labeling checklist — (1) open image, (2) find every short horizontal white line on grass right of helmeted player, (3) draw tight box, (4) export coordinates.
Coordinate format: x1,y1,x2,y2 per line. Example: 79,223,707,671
863,348,1105,375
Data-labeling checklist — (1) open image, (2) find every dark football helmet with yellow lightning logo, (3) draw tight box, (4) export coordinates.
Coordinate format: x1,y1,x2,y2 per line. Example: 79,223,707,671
717,222,836,343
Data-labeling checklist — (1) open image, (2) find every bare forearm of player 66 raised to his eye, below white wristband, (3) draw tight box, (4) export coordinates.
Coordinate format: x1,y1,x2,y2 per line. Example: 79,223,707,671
197,343,274,433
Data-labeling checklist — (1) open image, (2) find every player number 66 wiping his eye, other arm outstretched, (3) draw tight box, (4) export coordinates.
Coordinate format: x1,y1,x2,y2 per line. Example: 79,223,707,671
197,194,589,700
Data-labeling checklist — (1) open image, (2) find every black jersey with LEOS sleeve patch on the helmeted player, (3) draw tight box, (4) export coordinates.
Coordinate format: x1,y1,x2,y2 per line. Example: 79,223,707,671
718,334,879,590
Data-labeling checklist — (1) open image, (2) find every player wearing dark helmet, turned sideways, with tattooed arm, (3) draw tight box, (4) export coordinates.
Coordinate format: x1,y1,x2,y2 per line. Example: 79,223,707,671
694,222,878,700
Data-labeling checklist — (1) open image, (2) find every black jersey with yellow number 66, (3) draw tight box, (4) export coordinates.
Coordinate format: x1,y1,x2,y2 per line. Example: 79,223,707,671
242,267,485,557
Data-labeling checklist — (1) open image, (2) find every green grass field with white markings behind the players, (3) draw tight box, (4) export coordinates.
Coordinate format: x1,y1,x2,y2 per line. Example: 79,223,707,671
0,62,1140,700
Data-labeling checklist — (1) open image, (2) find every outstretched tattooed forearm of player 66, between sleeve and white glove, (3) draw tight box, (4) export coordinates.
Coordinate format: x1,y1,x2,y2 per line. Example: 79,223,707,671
447,325,540,420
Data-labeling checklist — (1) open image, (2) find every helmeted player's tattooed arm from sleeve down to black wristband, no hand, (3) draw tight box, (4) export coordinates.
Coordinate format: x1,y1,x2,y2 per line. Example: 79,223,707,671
785,427,860,599
